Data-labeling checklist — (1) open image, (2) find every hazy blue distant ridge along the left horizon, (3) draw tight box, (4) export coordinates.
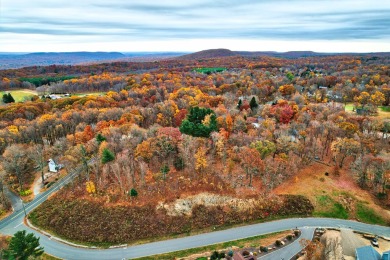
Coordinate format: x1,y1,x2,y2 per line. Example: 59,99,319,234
0,52,126,69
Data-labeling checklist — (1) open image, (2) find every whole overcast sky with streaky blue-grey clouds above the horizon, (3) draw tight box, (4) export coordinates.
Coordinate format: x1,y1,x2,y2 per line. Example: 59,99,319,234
0,0,390,52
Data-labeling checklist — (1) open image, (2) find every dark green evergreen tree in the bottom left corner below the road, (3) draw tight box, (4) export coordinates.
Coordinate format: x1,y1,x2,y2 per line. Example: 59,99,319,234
3,230,44,260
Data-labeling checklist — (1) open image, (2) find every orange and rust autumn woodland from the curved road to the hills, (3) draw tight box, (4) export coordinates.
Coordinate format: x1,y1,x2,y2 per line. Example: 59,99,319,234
0,54,390,245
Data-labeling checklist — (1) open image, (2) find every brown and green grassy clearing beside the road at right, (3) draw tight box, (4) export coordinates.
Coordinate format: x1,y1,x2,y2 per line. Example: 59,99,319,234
275,163,390,225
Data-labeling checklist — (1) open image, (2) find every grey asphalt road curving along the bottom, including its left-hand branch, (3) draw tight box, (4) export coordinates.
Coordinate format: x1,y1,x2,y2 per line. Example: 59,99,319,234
0,166,390,260
